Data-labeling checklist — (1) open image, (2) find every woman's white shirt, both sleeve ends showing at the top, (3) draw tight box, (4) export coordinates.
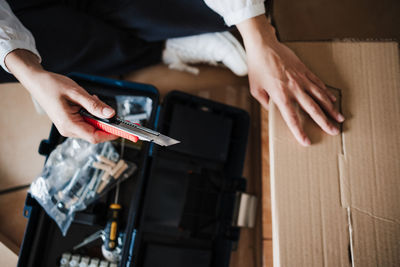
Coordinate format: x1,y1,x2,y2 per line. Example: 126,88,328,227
0,0,265,72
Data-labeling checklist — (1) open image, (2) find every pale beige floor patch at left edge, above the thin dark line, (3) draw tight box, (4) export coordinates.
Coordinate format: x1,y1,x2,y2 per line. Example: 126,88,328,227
0,83,51,190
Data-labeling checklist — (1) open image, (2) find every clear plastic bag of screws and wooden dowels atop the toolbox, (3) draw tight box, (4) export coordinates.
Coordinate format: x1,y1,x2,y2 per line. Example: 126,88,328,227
29,138,137,235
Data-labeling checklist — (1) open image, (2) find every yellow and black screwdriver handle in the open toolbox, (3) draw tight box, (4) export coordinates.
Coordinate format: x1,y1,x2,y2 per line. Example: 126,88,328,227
104,203,121,251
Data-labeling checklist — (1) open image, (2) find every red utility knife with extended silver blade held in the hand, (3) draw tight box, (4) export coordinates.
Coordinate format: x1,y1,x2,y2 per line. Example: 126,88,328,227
79,109,180,146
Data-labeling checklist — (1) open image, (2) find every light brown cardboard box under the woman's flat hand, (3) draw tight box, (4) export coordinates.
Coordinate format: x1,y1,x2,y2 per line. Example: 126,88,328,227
269,42,400,267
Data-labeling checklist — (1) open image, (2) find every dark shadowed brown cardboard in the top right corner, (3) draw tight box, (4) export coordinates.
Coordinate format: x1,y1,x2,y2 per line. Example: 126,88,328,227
271,0,400,41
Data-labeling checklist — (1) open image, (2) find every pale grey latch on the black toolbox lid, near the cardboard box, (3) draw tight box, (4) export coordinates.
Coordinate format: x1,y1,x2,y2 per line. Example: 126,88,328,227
232,192,257,228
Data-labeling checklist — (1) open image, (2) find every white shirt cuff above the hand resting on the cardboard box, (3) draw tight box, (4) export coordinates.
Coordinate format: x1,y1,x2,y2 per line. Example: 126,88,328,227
204,0,265,26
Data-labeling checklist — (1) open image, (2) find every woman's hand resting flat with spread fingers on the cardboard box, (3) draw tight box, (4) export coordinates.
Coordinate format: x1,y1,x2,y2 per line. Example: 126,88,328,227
237,15,344,146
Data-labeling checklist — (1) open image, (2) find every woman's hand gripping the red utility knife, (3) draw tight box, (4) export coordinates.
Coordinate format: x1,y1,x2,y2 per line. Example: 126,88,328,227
5,50,117,143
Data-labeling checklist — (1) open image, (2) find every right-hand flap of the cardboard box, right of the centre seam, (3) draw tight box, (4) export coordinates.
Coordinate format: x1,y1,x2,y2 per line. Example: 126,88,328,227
333,43,400,266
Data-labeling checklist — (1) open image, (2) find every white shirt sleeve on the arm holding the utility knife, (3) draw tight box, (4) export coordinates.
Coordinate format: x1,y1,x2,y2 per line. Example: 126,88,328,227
0,0,42,72
